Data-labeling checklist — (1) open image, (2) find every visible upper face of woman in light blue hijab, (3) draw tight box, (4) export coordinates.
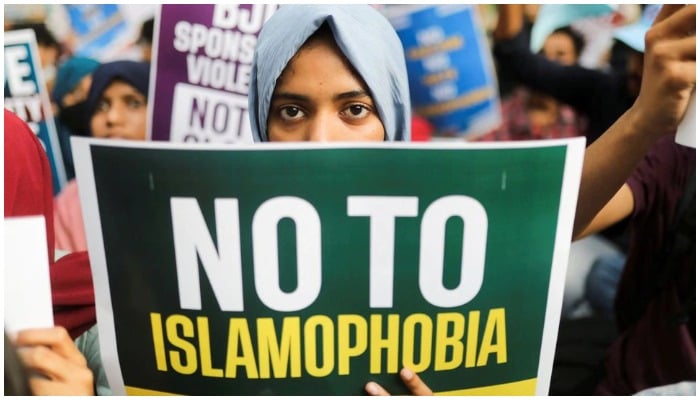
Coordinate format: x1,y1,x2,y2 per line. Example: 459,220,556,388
267,38,384,142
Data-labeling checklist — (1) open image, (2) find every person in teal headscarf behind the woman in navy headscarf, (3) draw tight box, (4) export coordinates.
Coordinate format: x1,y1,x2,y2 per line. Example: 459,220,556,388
51,56,100,180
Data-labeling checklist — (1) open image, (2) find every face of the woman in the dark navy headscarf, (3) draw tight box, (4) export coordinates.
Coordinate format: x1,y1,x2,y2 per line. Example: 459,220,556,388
90,81,146,140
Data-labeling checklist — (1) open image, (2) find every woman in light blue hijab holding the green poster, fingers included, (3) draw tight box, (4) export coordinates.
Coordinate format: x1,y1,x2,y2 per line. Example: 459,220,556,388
248,5,432,395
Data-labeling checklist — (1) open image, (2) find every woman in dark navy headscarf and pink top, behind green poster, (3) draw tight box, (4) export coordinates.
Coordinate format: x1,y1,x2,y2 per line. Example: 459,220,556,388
54,61,150,252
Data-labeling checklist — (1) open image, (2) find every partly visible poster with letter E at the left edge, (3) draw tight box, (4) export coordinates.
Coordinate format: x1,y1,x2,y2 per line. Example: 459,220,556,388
4,29,66,194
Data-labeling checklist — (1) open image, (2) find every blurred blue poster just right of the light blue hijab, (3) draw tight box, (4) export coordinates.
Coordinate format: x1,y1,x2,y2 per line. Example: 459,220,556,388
382,4,501,138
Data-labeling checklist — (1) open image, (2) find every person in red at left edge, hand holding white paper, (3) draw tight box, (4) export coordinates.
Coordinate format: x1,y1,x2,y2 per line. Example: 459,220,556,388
4,110,108,395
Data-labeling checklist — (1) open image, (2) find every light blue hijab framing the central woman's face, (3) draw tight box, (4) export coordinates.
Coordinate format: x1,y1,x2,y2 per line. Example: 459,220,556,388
248,4,411,142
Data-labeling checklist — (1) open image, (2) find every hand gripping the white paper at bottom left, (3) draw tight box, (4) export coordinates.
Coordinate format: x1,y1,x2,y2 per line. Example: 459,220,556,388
14,326,95,396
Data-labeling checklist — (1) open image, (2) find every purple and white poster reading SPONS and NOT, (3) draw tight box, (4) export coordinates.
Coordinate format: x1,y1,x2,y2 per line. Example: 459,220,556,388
149,4,277,143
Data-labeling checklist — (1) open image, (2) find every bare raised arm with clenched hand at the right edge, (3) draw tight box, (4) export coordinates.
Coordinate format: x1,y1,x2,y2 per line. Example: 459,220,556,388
573,4,696,239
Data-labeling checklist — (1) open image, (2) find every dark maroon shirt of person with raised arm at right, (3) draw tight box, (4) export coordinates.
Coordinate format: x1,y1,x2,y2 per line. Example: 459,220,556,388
598,135,696,395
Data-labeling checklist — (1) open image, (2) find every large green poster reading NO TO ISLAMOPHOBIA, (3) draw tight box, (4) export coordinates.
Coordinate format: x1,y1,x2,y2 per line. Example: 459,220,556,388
73,137,585,395
